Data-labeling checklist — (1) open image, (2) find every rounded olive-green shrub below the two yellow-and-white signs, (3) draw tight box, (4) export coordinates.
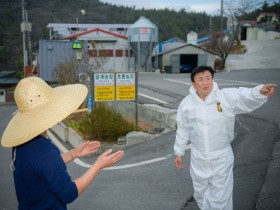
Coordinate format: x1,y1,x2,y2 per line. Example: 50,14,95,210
76,103,135,142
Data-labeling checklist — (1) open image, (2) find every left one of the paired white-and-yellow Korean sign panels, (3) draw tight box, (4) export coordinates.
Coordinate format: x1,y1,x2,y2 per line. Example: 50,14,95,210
94,73,115,101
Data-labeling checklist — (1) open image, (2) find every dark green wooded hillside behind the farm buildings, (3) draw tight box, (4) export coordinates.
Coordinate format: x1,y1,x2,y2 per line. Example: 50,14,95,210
0,0,278,71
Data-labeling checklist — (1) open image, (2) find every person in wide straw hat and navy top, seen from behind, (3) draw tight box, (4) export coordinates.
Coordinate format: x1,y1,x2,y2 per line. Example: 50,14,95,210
1,77,124,210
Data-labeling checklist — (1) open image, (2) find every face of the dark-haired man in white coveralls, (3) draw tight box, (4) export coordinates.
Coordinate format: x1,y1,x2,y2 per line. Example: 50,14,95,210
192,71,213,100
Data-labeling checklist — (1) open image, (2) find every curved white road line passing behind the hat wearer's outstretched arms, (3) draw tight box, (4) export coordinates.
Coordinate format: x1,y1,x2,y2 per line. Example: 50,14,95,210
48,131,191,171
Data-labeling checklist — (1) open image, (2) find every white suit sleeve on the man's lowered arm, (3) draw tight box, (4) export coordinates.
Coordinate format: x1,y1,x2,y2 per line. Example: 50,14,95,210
174,101,189,156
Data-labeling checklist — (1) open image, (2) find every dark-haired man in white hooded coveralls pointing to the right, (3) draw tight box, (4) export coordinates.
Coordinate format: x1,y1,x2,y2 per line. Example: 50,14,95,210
174,66,276,210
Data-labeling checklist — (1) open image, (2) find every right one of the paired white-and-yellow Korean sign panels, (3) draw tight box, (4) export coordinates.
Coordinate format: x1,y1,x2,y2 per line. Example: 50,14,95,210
116,73,135,101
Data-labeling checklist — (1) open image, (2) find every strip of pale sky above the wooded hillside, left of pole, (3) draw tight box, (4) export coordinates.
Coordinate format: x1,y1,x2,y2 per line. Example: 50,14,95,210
100,0,221,14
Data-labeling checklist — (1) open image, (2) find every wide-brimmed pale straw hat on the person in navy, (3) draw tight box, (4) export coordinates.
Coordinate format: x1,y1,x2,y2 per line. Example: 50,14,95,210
1,77,88,147
